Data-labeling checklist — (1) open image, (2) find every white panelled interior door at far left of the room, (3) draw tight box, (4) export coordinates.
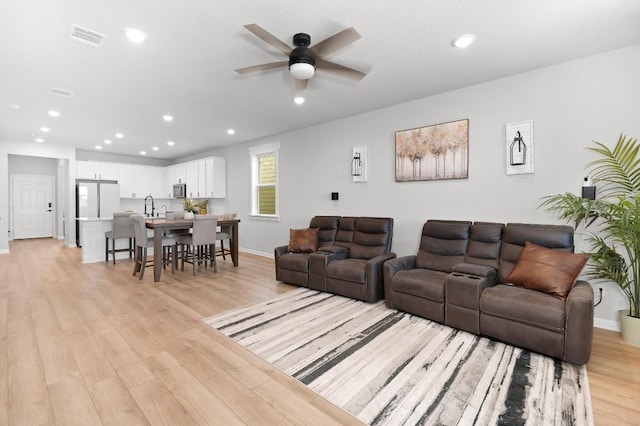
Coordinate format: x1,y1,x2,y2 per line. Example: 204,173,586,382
11,175,55,239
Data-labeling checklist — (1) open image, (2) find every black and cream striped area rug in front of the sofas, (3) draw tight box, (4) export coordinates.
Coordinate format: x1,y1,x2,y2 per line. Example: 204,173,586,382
203,288,593,425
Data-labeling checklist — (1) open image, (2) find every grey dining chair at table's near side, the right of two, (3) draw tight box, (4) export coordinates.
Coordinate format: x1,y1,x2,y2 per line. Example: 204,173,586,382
175,215,218,275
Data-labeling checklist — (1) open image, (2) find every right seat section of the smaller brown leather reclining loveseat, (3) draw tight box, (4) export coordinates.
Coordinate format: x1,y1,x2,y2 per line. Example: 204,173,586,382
322,217,396,302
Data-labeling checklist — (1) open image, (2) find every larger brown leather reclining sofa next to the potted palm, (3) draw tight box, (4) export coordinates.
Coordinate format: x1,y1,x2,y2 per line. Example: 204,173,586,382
383,220,593,365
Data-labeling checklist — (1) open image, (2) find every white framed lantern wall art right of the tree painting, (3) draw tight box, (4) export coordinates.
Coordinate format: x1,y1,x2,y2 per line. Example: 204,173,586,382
505,120,533,175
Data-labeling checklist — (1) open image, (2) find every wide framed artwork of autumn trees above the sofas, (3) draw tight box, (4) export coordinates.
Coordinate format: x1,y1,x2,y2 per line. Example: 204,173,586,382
396,119,469,182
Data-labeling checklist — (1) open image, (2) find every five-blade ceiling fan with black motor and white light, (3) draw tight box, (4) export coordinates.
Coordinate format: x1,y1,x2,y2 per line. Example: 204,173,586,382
236,24,366,90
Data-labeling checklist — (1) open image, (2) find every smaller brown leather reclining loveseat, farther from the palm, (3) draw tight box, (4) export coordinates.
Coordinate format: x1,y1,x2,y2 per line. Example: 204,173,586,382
274,216,396,302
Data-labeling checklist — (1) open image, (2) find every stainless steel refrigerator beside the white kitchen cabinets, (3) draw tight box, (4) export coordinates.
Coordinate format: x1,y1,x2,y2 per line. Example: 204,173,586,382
76,179,120,247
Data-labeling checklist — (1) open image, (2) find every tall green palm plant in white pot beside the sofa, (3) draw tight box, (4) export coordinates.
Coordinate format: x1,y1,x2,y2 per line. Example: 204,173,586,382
542,134,640,346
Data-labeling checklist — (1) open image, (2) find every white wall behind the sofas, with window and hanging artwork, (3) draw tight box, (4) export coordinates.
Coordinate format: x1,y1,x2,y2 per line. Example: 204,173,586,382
221,45,640,328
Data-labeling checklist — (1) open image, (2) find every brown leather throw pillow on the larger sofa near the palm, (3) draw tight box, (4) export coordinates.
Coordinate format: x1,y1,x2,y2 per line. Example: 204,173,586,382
506,241,589,299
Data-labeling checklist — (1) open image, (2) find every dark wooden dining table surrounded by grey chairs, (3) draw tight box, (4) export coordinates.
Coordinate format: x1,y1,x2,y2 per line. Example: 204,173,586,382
145,218,240,282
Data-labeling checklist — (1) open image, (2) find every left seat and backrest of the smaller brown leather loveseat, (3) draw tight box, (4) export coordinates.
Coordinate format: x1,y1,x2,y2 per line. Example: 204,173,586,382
273,216,340,287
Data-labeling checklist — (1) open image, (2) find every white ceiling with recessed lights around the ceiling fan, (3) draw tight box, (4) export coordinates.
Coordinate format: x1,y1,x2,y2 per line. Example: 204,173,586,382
0,0,640,160
